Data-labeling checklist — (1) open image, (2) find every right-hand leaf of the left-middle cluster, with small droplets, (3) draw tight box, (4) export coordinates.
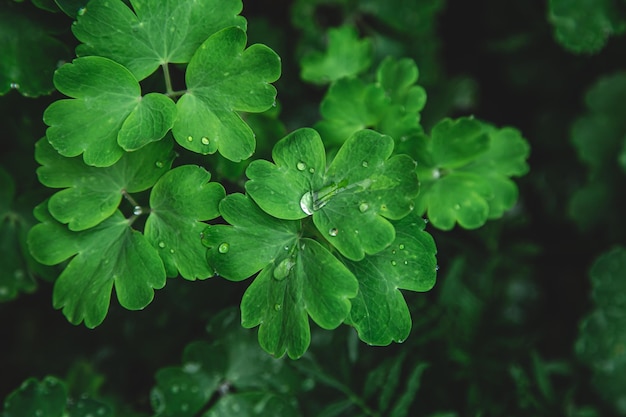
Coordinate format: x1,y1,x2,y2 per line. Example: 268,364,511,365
144,165,226,280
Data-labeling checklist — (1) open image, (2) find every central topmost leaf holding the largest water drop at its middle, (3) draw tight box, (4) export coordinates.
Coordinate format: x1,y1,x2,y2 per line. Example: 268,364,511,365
246,129,418,260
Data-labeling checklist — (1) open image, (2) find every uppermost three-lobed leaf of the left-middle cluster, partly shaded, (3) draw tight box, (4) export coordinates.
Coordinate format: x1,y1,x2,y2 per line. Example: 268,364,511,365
35,138,174,231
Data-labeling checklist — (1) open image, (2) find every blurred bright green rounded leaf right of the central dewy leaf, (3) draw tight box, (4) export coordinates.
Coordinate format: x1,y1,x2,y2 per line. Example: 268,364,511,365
415,118,529,230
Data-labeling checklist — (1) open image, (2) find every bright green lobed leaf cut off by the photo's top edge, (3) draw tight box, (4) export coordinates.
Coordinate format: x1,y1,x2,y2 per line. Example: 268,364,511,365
72,0,246,80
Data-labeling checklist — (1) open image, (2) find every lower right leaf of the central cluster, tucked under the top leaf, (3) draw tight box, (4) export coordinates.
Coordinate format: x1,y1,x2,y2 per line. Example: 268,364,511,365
346,213,437,345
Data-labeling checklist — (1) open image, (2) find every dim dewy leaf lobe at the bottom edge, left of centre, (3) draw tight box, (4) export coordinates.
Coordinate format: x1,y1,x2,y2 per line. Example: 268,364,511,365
203,392,300,417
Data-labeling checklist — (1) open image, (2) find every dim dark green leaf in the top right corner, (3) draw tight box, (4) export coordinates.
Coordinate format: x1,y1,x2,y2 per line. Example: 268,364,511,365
548,0,626,53
